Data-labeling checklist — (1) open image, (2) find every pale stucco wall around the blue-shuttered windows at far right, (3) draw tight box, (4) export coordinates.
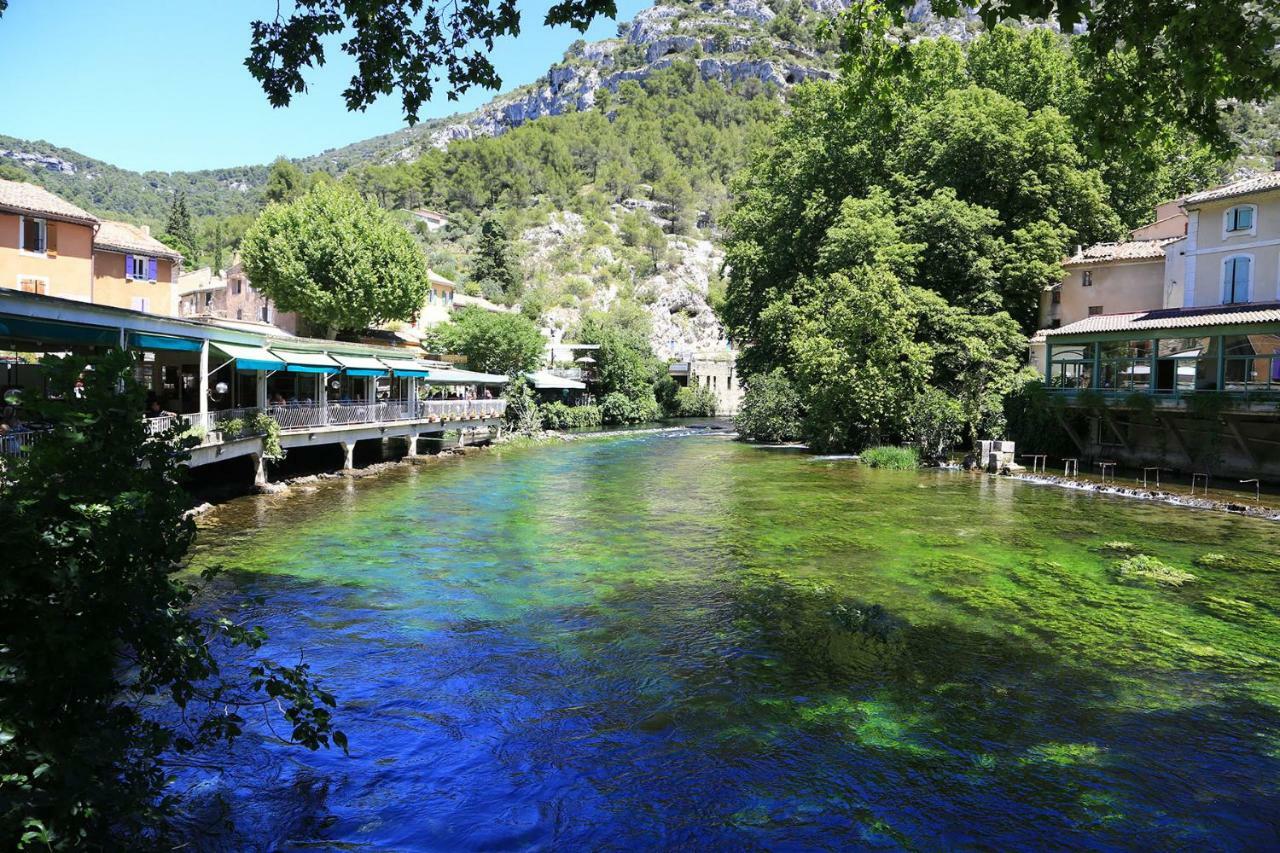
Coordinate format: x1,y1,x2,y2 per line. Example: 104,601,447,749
1183,192,1280,307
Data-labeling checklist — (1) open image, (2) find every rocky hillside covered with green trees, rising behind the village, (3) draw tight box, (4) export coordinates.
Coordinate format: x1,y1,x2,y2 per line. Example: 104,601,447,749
0,0,1280,355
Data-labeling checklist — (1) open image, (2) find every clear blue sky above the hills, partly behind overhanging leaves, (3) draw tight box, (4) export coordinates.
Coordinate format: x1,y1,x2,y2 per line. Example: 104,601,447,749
0,0,648,170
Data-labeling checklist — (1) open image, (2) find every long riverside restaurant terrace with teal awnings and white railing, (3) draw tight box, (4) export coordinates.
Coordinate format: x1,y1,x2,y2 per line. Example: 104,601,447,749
0,289,507,483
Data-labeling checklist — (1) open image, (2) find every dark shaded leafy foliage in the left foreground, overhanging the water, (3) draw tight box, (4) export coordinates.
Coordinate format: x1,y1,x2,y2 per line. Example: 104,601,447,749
0,351,346,849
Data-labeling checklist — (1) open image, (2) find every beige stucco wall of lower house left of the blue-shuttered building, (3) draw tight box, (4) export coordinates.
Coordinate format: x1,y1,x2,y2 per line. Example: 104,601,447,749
1039,259,1165,329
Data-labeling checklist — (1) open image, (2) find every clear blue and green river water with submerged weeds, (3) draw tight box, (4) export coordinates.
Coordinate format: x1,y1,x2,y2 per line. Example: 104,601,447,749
182,432,1280,850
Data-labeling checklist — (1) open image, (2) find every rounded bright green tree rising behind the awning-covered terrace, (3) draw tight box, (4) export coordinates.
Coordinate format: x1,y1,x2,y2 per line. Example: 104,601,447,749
242,184,429,333
